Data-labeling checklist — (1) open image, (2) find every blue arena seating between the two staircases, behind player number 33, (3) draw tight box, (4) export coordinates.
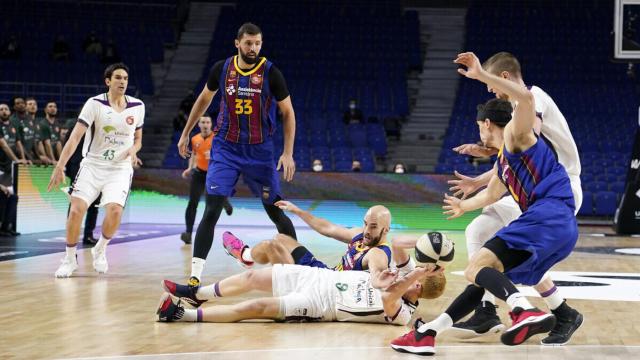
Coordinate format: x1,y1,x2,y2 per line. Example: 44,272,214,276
164,1,421,172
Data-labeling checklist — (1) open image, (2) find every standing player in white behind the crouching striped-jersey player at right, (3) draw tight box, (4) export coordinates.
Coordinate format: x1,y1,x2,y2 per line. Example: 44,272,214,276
448,52,583,345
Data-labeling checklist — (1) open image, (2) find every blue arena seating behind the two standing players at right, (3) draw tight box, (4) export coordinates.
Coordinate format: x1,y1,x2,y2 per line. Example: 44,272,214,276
436,1,639,216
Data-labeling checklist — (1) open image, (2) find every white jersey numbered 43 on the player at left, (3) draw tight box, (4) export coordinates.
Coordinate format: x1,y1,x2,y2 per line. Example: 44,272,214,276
78,93,145,167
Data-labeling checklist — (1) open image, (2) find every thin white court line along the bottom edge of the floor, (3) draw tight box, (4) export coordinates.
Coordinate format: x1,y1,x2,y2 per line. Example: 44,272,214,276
66,344,640,360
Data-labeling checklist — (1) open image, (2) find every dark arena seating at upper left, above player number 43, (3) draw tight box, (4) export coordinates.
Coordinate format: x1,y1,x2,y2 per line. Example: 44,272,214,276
0,0,176,111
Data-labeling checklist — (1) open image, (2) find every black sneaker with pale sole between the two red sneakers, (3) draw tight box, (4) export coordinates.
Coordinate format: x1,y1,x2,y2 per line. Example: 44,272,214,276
448,301,505,339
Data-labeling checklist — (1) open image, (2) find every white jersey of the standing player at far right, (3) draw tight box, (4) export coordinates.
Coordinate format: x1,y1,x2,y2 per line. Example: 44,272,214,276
531,86,581,177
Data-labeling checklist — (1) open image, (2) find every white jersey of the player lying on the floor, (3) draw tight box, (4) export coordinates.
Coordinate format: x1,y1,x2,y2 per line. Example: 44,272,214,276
332,271,417,325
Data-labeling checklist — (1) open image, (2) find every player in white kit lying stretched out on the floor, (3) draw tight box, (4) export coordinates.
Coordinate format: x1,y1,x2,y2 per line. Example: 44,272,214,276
157,264,444,325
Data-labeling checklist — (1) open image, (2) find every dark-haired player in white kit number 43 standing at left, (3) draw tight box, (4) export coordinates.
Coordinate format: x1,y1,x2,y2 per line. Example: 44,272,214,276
48,63,145,277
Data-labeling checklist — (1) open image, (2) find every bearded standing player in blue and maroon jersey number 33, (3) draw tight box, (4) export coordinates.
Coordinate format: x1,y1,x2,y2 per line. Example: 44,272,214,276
178,23,296,288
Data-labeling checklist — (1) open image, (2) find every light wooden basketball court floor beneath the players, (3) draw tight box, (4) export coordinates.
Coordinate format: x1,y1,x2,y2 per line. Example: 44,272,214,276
0,228,640,360
